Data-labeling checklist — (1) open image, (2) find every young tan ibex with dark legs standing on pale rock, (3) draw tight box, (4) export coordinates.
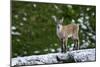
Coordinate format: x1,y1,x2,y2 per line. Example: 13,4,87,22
52,16,79,52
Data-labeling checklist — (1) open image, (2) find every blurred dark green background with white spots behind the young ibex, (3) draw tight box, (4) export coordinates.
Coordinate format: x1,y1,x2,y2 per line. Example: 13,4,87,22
11,1,96,57
